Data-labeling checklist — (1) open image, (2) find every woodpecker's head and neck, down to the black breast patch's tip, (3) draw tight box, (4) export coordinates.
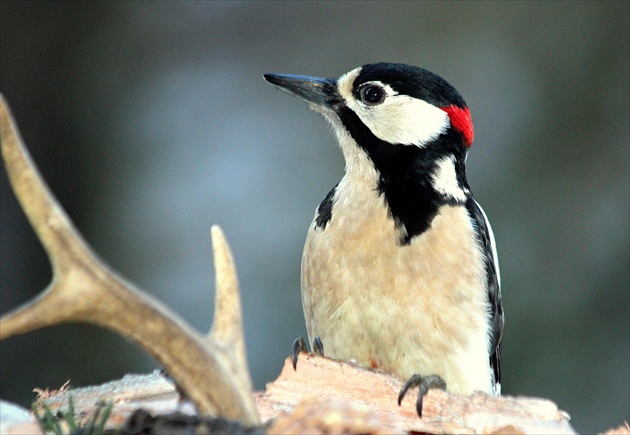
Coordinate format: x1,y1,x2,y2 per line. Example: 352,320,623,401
264,63,474,243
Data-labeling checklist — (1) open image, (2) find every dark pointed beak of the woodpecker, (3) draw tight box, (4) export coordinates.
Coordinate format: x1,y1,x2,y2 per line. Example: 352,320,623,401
264,74,336,106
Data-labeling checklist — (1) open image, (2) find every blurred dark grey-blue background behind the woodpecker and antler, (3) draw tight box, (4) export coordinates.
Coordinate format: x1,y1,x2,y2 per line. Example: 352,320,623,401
0,0,630,432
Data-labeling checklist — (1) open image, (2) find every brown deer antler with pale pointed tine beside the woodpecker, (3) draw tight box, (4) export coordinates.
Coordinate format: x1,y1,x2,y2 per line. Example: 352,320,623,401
0,95,259,425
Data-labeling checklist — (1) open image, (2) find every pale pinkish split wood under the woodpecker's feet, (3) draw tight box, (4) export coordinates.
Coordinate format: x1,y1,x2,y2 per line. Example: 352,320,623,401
257,353,575,434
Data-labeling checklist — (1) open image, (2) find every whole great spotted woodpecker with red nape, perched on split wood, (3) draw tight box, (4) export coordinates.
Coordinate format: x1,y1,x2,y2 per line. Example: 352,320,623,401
264,63,503,415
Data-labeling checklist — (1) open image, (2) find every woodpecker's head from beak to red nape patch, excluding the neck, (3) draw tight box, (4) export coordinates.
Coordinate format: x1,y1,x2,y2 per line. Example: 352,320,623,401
264,63,474,157
